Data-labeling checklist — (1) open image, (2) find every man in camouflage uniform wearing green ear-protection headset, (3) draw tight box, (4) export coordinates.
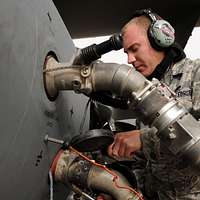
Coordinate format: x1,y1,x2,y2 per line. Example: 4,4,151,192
97,10,200,200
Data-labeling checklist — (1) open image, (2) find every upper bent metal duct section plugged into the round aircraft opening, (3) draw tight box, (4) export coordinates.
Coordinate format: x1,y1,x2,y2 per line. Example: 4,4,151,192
44,56,148,98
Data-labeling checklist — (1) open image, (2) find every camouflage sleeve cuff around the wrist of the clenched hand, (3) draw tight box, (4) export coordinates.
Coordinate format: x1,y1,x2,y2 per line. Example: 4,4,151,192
140,127,160,160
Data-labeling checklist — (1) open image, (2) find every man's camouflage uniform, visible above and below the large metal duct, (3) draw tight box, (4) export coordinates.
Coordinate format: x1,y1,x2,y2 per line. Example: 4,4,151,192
141,58,200,200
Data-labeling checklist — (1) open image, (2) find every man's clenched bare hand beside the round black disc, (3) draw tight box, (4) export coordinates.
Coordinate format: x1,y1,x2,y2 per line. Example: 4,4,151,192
108,130,142,159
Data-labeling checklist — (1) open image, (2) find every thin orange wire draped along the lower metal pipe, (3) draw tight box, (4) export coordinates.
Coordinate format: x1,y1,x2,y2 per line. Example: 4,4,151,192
69,146,144,200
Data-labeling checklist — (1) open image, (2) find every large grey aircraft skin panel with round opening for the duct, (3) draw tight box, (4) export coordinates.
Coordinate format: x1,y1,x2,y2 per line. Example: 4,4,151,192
0,0,89,200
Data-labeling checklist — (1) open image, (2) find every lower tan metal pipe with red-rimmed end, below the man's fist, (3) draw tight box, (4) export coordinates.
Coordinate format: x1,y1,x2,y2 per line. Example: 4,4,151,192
51,150,142,200
